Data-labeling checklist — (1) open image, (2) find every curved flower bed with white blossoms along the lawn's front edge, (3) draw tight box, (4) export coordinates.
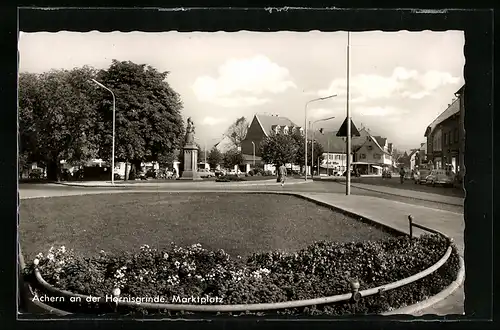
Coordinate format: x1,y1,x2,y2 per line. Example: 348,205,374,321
25,235,459,315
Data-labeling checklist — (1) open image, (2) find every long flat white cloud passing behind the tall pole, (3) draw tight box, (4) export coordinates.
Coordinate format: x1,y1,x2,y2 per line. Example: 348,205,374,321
317,67,460,102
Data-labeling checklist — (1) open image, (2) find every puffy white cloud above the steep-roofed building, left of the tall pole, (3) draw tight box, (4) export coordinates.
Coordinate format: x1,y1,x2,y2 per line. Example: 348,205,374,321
192,55,297,107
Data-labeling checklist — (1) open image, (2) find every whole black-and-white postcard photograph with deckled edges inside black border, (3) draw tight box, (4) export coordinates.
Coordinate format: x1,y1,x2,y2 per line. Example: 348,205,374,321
18,10,467,318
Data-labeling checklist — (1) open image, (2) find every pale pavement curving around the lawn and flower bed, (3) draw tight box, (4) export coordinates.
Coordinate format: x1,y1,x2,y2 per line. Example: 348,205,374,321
19,180,464,315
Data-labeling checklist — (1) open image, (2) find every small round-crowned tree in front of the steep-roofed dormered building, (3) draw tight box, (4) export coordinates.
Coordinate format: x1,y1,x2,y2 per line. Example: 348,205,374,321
260,134,298,166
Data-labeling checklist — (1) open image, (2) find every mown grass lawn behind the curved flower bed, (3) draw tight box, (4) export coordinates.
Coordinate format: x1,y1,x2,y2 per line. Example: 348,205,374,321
19,193,389,259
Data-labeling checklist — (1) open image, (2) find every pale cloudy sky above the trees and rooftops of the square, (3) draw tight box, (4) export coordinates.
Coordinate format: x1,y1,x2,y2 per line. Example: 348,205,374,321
19,31,465,149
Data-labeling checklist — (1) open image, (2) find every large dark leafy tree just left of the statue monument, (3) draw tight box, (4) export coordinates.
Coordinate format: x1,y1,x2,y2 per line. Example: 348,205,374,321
94,60,184,178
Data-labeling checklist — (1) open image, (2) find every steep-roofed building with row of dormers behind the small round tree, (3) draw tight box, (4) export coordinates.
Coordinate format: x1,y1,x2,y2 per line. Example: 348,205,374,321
241,114,303,171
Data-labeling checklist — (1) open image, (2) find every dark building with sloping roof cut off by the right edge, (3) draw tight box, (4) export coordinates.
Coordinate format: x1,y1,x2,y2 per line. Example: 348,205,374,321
424,85,465,179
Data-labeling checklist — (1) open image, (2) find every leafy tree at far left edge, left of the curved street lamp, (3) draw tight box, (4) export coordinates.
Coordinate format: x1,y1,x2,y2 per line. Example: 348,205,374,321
19,66,100,180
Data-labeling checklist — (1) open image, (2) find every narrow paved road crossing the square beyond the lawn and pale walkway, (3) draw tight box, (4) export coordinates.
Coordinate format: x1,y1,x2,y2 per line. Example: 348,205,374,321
19,180,464,214
